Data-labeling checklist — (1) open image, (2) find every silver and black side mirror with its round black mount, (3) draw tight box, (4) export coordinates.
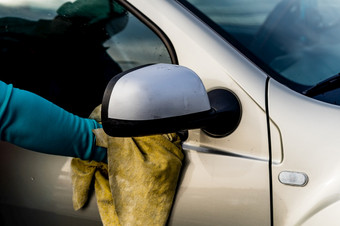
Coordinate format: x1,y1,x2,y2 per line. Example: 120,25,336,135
102,64,241,137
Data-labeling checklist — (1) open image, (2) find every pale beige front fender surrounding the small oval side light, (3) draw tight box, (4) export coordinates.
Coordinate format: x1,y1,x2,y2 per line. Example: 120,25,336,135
268,80,340,225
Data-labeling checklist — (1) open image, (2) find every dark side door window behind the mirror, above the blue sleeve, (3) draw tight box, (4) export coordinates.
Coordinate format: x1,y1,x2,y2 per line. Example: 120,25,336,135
0,0,172,117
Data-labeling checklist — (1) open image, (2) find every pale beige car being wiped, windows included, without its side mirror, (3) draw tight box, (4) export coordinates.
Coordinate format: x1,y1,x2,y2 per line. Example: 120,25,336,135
0,0,340,226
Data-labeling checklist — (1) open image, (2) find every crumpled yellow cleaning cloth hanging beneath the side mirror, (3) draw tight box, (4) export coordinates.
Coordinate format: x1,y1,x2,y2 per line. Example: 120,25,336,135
71,107,183,225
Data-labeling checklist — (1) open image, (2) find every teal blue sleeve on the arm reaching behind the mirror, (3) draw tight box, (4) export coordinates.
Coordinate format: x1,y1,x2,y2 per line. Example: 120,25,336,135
0,81,107,162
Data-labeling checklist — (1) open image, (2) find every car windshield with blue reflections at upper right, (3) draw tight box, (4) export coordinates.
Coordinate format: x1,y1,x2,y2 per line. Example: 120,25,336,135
179,0,340,104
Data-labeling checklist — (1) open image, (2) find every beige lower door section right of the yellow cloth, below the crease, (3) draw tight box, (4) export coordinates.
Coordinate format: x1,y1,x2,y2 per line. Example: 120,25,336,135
169,145,270,225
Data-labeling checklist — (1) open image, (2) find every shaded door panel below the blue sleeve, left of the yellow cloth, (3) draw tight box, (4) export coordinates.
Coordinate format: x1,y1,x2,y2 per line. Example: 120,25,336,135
0,142,102,225
